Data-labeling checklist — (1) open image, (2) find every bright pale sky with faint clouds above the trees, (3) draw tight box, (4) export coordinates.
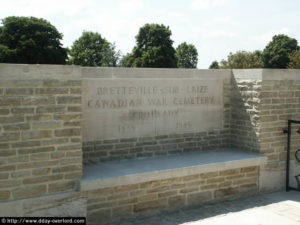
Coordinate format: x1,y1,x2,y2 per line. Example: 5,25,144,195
0,0,300,69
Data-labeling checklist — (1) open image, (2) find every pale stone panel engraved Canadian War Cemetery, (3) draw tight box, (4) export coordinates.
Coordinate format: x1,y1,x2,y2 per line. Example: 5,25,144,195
83,78,223,141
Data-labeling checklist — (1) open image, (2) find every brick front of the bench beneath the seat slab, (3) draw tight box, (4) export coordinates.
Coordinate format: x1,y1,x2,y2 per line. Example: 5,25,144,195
83,166,259,224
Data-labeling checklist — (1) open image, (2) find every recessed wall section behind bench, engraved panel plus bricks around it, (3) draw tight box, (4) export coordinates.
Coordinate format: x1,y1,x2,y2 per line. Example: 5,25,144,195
83,68,230,162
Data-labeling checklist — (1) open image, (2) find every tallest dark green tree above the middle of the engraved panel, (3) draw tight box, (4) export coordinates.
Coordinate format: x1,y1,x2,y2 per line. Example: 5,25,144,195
122,24,177,68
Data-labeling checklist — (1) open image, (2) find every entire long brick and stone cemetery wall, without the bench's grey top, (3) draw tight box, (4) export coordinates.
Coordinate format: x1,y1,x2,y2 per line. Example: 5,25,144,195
0,64,300,224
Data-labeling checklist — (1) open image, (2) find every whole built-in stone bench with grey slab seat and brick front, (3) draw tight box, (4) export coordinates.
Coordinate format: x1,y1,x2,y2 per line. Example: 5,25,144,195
80,148,267,221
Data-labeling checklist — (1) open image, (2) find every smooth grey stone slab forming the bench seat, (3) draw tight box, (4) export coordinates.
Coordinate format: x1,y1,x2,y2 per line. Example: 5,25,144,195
80,148,267,191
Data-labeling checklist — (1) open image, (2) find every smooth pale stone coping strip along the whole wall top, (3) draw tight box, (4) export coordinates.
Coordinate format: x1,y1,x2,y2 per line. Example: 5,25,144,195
0,63,300,81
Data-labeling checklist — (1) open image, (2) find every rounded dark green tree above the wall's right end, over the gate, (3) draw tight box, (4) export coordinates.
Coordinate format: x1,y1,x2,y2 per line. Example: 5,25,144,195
262,34,299,68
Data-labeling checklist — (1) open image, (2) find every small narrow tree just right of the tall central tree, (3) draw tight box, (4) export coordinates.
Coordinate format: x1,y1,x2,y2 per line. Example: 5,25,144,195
176,42,198,68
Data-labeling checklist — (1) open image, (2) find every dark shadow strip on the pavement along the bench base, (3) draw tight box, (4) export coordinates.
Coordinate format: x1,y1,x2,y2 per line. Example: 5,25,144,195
110,191,300,225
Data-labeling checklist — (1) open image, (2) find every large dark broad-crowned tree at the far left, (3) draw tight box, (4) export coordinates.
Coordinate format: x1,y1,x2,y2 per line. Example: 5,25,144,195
0,16,67,64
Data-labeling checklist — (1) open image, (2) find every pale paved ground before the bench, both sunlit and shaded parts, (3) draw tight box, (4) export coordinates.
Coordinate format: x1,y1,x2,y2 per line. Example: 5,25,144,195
113,191,300,225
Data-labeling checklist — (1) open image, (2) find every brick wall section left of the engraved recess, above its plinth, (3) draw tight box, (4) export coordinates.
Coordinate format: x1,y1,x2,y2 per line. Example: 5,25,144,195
0,64,82,201
